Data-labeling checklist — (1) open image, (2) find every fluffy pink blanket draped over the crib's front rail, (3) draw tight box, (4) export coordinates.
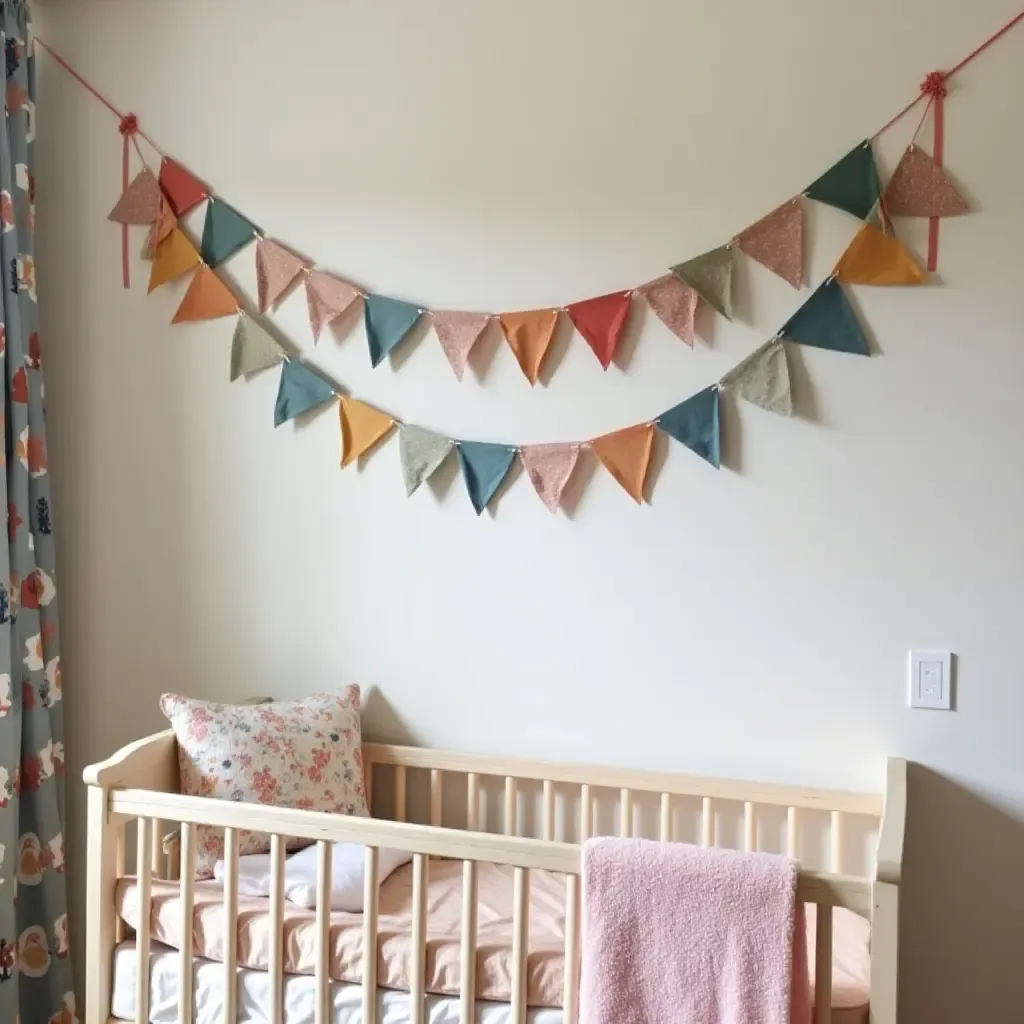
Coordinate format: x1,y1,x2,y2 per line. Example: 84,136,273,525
580,839,811,1024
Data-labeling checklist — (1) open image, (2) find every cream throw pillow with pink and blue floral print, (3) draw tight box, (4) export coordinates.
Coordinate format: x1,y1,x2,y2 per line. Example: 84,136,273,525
160,686,369,879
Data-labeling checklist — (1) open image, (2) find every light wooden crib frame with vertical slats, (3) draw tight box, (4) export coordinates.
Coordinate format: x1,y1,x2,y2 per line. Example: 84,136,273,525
84,730,906,1024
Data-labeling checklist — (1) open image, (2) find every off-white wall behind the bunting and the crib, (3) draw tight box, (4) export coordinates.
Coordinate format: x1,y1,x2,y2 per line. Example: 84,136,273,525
37,0,1024,1024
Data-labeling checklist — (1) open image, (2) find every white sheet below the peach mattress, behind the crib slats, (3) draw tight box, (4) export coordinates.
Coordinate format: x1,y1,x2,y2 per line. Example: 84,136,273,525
111,939,562,1024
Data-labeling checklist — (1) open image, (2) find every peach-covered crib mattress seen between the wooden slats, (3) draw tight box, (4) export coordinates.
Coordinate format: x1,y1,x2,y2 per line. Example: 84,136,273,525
117,860,870,1024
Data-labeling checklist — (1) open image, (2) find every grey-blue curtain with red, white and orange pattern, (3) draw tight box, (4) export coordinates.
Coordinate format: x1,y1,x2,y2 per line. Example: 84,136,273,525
0,0,75,1024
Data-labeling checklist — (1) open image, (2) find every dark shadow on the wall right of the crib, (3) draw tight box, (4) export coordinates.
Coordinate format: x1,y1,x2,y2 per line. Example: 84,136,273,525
899,764,1024,1024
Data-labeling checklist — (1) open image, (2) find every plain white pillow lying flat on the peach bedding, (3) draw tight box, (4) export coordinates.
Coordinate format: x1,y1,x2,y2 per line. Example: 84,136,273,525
213,843,413,913
